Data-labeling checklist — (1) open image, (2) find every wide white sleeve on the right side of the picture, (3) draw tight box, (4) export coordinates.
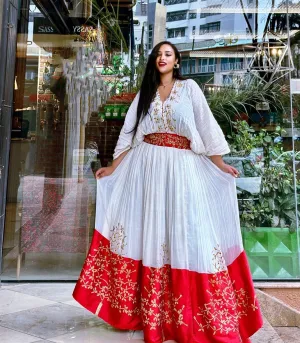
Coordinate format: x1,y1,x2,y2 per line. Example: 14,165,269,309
189,80,230,156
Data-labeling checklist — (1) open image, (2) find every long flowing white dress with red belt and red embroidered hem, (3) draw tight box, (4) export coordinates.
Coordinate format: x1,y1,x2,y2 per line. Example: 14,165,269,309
73,79,262,343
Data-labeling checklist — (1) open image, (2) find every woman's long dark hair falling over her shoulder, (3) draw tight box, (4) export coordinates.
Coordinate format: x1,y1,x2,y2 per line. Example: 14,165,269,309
132,41,184,134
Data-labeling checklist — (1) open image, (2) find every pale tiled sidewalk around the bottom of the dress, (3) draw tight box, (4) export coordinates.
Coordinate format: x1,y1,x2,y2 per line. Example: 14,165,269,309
0,283,300,343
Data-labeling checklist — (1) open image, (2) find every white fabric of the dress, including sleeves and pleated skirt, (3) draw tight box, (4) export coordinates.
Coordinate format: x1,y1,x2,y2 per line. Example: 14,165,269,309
95,80,243,273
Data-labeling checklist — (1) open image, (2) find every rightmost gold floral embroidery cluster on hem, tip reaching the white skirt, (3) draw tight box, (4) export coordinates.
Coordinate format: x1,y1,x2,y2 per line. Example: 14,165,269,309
194,247,258,335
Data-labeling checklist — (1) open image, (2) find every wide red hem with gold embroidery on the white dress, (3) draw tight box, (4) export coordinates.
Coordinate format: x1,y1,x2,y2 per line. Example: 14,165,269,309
73,230,263,343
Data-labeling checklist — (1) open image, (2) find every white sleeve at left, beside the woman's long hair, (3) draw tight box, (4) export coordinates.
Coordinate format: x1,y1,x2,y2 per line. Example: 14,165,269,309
113,92,140,160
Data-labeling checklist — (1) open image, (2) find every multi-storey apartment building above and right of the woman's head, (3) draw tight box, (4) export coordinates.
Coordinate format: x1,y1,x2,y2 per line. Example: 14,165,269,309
135,0,254,85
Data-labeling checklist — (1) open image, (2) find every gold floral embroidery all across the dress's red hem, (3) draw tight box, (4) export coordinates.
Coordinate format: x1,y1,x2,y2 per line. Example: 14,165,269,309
79,238,258,335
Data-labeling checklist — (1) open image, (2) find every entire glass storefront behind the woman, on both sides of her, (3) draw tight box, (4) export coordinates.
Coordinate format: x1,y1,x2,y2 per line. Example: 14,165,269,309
2,0,300,280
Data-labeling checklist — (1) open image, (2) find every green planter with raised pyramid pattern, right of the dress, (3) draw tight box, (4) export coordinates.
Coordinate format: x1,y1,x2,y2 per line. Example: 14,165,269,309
242,227,300,279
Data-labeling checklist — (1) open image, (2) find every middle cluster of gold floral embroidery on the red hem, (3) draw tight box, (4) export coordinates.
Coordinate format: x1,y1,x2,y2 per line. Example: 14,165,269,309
141,265,187,330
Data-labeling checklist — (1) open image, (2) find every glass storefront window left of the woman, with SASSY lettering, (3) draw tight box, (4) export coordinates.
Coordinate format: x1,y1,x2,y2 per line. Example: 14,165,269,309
2,1,132,280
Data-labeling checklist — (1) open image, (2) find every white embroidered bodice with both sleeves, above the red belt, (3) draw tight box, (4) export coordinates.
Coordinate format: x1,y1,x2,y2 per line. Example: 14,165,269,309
114,79,230,159
